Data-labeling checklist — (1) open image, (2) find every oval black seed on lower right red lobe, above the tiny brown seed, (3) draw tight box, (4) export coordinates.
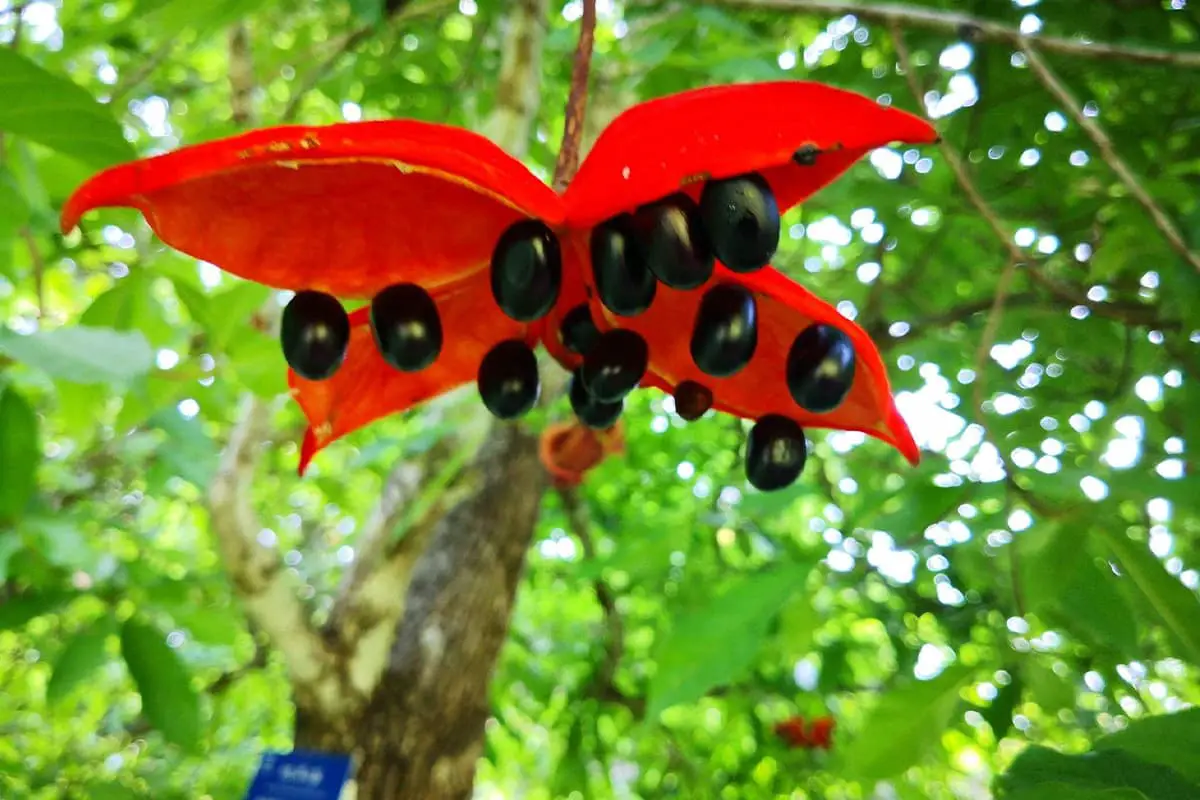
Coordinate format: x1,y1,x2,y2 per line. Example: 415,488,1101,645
691,283,758,378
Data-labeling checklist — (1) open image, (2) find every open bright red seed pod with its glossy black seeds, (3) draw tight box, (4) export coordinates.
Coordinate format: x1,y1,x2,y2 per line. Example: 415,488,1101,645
61,82,936,491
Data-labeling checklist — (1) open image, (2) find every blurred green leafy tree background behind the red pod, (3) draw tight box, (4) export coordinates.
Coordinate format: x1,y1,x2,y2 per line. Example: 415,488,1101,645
0,0,1200,800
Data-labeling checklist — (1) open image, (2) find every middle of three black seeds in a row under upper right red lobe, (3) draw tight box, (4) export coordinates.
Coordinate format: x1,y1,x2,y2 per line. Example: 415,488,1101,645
634,193,713,289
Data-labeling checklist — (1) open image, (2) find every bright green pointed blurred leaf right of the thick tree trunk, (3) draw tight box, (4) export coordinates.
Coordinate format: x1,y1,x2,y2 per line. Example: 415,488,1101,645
646,564,811,720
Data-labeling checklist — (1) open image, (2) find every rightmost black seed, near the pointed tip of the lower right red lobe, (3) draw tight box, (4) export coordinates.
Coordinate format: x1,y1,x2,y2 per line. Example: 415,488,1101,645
787,325,856,414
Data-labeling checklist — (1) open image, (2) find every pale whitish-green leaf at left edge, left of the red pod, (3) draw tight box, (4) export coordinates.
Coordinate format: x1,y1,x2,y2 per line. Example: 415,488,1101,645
0,326,154,384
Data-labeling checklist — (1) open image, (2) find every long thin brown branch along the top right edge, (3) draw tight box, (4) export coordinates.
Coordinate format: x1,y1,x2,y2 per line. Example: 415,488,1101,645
704,0,1200,70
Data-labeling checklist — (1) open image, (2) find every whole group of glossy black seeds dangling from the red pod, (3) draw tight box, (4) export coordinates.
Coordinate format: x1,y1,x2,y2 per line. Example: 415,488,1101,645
282,146,856,491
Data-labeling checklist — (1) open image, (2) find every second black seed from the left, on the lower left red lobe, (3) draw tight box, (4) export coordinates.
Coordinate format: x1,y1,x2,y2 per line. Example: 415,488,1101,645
371,283,442,372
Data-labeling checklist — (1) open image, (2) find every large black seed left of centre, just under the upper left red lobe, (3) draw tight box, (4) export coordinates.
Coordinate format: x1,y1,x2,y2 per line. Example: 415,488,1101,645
492,219,563,323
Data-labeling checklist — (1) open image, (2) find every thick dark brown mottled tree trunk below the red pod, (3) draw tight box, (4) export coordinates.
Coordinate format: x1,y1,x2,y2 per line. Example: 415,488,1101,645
296,426,546,800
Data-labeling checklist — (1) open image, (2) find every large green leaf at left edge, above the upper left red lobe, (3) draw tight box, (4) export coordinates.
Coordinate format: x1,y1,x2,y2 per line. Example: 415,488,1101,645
0,48,134,168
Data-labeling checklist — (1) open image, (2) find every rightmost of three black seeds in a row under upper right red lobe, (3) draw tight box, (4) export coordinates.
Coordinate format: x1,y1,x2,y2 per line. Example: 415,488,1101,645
700,173,779,272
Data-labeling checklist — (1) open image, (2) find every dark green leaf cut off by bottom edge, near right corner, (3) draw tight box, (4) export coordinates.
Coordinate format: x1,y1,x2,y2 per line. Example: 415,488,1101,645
998,746,1200,800
